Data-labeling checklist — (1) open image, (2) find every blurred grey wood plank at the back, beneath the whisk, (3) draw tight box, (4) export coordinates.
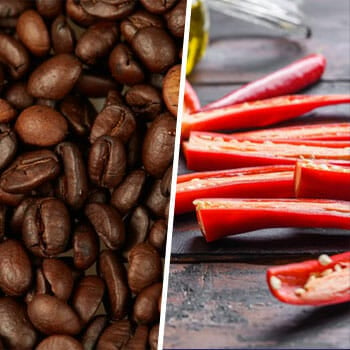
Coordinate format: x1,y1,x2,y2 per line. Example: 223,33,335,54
190,0,350,84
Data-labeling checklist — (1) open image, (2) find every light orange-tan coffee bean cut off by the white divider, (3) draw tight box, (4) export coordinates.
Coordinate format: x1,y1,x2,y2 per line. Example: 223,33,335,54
163,64,181,117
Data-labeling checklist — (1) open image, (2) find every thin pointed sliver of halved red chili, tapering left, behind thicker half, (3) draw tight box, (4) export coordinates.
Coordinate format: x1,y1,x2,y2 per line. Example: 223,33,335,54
232,123,350,141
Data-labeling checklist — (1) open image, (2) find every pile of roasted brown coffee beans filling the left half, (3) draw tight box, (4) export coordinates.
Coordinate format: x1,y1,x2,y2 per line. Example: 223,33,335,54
0,0,186,350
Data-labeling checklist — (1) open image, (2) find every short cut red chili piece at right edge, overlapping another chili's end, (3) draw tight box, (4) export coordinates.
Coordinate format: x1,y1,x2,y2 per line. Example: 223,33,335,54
295,161,350,201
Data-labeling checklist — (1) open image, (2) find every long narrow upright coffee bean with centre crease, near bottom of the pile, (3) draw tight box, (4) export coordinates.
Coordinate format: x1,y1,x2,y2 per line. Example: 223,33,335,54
98,250,130,320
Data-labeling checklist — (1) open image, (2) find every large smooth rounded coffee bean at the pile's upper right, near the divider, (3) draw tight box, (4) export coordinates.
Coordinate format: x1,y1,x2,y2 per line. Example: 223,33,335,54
131,27,177,73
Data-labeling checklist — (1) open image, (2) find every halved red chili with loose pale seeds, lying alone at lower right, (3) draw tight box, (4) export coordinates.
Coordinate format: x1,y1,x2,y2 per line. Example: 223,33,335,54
266,252,350,305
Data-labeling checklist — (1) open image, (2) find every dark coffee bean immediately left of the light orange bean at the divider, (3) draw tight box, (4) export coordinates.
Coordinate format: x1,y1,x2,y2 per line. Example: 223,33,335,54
125,84,163,120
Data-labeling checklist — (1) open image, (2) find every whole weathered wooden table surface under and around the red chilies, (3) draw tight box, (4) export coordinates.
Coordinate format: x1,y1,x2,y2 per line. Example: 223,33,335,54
164,0,350,349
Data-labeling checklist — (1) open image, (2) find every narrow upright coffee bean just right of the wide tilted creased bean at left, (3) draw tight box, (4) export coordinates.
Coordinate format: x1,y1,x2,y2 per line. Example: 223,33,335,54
56,142,88,209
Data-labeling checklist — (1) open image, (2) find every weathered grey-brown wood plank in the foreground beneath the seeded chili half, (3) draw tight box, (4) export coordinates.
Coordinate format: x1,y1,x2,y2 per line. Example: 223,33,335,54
164,263,350,349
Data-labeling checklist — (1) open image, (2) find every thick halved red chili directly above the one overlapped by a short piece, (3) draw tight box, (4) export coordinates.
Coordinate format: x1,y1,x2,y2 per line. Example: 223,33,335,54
183,132,350,171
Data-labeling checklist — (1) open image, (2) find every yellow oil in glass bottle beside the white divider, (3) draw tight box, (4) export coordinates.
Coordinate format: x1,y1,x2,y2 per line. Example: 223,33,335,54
186,0,209,74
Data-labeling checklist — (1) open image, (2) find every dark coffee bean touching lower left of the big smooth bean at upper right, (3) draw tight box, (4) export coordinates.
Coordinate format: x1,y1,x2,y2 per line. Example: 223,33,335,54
109,44,145,85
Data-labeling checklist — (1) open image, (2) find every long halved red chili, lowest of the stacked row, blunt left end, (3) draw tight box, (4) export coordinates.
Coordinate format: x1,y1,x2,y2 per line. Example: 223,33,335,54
194,198,350,242
